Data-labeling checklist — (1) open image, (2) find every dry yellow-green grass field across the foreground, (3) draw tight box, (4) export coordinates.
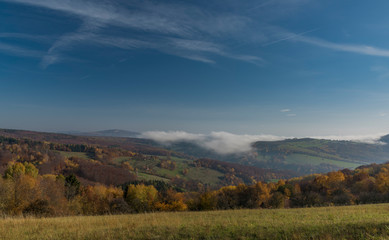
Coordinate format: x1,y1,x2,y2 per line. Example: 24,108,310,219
0,204,389,239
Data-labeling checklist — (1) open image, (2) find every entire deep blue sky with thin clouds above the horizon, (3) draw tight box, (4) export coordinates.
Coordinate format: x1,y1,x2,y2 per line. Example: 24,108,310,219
0,0,389,139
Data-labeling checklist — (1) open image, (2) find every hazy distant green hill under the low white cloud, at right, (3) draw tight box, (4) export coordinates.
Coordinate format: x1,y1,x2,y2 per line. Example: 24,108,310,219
155,135,389,176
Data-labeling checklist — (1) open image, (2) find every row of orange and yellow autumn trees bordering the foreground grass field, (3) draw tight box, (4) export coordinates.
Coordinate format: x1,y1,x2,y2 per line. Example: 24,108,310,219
0,159,389,216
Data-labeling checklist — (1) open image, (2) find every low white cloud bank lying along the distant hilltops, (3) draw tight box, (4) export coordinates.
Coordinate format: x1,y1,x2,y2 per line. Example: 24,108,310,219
139,131,384,154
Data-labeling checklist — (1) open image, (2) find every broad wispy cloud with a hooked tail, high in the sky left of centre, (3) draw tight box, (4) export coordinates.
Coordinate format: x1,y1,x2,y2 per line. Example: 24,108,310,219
5,0,263,67
